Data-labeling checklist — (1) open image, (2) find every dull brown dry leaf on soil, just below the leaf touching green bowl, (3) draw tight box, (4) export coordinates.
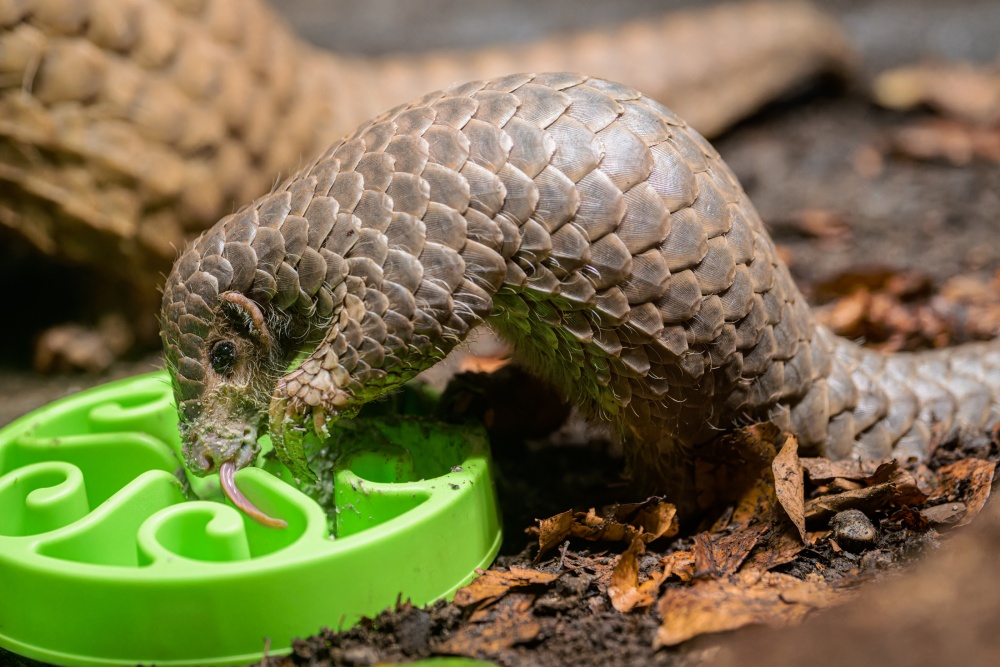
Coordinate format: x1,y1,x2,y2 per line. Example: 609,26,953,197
434,593,541,658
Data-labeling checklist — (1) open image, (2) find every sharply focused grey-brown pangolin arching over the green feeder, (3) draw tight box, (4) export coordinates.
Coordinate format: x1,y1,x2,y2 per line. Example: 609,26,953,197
162,74,1000,512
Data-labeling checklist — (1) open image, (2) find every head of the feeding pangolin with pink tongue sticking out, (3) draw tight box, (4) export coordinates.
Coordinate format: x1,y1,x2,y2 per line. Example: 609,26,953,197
160,219,287,525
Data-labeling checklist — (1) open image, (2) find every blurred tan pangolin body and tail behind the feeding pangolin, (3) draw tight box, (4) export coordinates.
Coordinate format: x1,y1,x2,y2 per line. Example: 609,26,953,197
0,0,849,302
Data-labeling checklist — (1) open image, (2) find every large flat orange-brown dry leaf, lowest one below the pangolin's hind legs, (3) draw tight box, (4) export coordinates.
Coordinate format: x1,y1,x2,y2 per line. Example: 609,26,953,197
655,572,846,647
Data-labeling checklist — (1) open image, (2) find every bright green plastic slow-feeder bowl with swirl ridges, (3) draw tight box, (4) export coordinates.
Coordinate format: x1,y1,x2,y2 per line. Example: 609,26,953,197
0,373,500,665
